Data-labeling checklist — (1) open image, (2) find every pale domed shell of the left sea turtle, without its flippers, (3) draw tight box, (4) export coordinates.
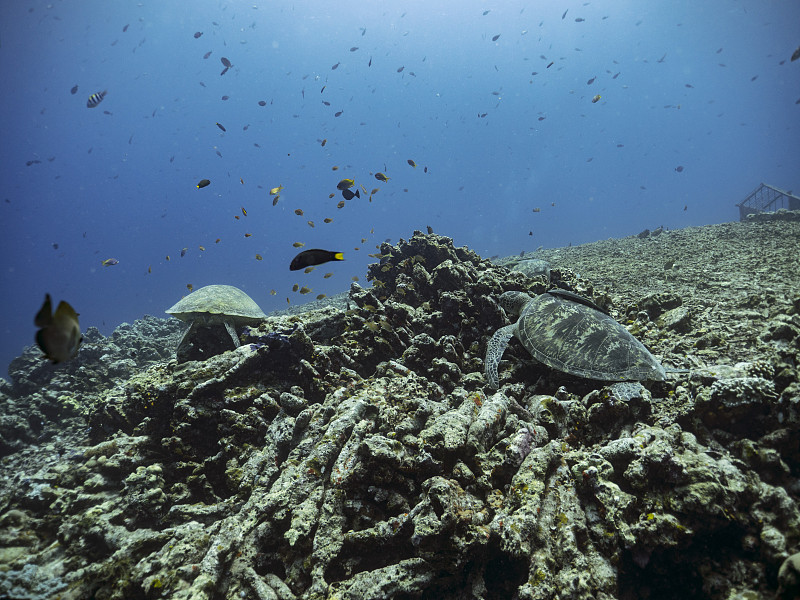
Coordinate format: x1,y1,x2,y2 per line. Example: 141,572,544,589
165,285,266,326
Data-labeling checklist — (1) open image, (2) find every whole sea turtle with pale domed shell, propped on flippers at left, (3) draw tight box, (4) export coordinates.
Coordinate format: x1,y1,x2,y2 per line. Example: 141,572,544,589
165,285,266,362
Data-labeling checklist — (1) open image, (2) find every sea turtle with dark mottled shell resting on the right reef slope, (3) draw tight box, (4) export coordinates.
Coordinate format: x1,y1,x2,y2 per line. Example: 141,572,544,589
485,289,666,389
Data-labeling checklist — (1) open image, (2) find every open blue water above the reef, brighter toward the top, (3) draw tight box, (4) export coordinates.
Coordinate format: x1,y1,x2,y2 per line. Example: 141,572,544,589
0,0,800,380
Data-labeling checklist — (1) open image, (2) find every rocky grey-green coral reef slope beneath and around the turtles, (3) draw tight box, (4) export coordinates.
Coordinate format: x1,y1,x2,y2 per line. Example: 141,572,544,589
0,215,800,600
